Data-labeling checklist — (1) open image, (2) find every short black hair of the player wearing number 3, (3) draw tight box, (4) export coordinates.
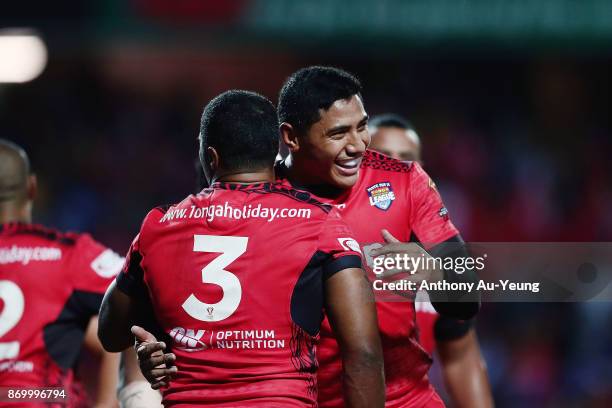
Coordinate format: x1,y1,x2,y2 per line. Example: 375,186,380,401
200,90,279,170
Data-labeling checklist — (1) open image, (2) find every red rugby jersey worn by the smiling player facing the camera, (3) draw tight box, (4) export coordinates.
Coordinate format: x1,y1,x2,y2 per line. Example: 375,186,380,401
278,150,458,407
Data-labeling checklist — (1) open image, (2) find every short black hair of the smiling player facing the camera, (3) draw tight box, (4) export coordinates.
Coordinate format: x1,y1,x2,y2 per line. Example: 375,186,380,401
278,66,361,132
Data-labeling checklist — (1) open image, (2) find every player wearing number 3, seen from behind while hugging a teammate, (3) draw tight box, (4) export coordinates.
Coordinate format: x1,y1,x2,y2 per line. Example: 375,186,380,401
99,91,384,408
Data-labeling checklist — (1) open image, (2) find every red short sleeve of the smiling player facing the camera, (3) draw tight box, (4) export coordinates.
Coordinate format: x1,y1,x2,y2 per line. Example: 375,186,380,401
408,162,459,249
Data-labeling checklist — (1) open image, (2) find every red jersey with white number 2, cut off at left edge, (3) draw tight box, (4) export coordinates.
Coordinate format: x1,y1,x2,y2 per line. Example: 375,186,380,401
0,223,123,407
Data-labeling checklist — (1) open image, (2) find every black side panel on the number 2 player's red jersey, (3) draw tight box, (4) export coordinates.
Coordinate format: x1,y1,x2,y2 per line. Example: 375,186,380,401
43,290,104,369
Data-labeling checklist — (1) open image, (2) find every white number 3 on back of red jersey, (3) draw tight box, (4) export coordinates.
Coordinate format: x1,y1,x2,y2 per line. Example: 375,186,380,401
183,235,249,322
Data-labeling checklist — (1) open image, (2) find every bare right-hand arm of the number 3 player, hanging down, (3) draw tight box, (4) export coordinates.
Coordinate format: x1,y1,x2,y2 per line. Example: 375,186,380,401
325,268,385,408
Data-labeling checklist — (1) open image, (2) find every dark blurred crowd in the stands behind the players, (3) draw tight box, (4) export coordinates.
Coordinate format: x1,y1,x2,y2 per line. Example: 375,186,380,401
0,50,612,407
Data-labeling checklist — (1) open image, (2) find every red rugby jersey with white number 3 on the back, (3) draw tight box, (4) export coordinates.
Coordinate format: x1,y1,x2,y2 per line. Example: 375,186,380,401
117,183,361,407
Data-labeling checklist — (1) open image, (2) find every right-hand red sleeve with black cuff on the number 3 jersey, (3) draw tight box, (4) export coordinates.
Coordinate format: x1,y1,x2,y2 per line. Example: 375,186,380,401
319,208,362,279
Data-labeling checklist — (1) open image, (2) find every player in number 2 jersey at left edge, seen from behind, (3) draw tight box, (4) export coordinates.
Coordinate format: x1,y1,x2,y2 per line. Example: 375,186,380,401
0,139,123,407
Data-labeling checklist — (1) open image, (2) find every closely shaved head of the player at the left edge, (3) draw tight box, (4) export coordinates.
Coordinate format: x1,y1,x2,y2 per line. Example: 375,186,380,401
0,139,31,203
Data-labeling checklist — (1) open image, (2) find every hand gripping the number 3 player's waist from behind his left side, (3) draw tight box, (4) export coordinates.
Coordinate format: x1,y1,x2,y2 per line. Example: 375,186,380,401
131,326,177,390
